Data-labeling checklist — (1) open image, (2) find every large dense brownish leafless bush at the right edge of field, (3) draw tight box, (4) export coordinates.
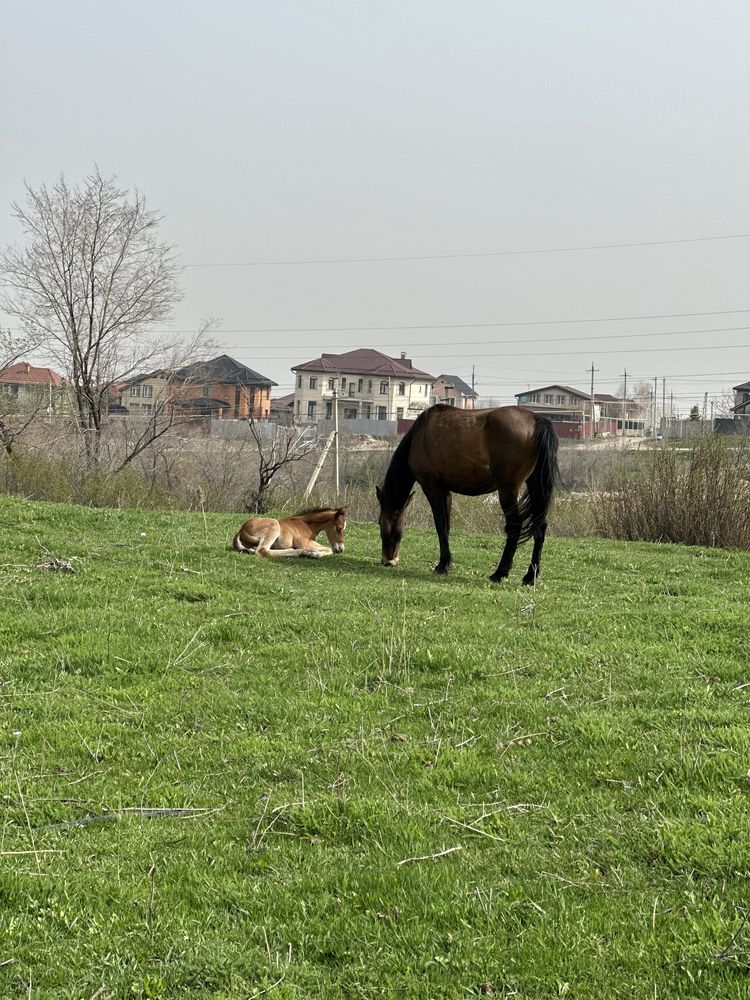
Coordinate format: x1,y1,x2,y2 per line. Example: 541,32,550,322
594,434,750,549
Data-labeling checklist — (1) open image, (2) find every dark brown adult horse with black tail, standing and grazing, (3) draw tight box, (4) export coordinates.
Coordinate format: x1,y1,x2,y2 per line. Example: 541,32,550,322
376,403,558,584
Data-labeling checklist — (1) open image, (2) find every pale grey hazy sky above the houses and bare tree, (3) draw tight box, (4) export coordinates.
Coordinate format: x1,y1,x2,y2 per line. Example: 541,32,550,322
0,0,750,410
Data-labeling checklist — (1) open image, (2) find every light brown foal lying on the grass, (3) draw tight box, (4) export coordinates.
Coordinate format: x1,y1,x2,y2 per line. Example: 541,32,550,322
233,507,346,559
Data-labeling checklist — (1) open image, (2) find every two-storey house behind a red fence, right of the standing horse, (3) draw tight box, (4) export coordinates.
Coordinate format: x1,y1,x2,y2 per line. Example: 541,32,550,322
516,384,645,439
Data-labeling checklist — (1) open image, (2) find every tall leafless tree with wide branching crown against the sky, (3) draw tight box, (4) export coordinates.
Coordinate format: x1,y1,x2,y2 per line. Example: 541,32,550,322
0,168,197,466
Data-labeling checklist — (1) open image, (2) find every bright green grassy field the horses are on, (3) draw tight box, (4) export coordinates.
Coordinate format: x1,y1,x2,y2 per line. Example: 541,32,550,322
0,497,750,1000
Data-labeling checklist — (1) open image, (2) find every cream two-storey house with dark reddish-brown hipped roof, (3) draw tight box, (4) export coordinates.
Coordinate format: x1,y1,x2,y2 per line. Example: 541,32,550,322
292,347,435,423
